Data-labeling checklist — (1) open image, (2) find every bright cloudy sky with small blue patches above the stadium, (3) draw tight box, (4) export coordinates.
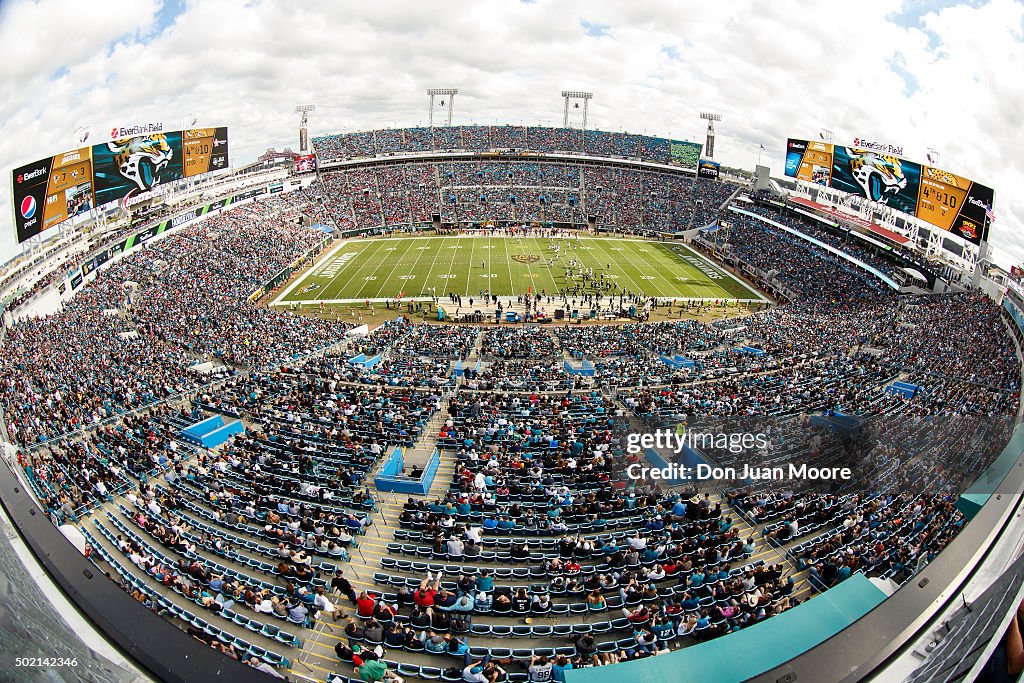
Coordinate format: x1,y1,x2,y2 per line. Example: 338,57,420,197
0,0,1024,266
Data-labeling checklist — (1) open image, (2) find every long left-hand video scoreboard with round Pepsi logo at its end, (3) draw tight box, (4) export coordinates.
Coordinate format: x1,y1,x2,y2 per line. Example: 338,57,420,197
11,127,228,243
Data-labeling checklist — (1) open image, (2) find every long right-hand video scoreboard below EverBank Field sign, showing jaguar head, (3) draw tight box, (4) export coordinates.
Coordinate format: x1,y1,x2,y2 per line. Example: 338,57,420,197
785,138,995,245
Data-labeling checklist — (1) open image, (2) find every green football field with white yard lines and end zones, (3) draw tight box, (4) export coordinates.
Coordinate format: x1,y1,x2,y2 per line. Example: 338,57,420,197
274,236,763,304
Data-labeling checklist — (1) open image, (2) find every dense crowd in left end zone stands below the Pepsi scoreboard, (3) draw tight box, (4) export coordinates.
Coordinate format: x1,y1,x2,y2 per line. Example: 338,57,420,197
0,196,350,444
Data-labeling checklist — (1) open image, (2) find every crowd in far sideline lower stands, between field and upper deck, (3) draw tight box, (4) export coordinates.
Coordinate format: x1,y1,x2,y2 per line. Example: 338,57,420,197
303,161,736,233
